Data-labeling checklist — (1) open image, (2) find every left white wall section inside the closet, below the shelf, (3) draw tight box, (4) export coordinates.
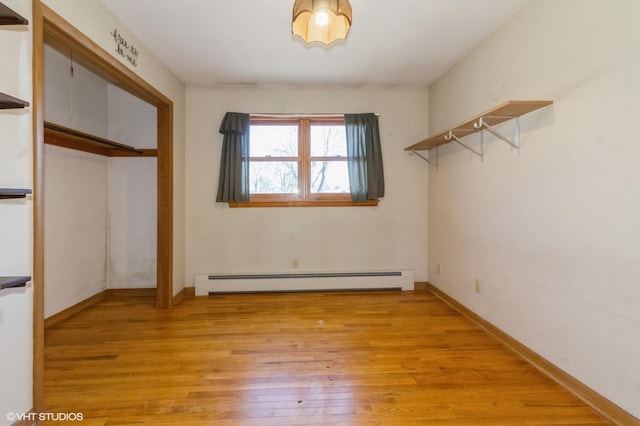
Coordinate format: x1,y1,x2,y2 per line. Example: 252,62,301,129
44,145,108,318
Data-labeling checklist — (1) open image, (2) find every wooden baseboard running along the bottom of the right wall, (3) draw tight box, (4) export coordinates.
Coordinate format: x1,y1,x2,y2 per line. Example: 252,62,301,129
427,283,640,426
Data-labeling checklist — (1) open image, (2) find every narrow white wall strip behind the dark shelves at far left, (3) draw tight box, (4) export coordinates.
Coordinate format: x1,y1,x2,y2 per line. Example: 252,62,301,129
0,0,33,426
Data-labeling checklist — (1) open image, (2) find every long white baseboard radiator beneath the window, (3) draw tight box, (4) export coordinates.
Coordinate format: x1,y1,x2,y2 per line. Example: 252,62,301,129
195,270,414,296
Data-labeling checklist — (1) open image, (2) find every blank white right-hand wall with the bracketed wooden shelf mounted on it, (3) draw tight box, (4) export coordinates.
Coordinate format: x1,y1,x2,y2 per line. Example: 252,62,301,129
429,0,640,417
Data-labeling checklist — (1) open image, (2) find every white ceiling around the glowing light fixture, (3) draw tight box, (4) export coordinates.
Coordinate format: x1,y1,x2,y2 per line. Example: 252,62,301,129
102,0,526,86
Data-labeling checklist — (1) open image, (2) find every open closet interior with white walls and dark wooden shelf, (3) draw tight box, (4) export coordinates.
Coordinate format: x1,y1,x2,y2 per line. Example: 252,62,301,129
44,40,157,318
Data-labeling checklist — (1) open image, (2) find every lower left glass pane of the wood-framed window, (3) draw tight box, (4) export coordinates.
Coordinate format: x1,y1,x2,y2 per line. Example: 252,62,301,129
249,161,298,194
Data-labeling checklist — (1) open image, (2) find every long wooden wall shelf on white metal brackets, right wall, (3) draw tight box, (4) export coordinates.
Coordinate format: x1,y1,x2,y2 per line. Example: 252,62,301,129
405,100,553,151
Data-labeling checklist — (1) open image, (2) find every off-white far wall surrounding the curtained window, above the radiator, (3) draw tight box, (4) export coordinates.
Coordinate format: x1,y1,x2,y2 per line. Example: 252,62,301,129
186,87,427,285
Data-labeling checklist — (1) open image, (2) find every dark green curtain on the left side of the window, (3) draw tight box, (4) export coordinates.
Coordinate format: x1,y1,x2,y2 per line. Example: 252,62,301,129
216,112,250,203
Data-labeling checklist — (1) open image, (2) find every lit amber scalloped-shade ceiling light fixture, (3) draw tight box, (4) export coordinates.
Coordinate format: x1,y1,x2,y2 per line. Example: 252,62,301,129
291,0,351,45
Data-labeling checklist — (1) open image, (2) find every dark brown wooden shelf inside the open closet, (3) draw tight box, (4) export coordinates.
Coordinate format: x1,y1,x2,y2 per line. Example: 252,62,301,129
44,121,157,157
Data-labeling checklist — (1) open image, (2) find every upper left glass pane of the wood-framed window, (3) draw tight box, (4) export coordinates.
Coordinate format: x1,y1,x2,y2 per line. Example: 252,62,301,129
249,125,298,157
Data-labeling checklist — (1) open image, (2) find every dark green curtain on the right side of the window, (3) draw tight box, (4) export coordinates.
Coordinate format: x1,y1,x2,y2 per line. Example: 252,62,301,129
344,113,384,203
